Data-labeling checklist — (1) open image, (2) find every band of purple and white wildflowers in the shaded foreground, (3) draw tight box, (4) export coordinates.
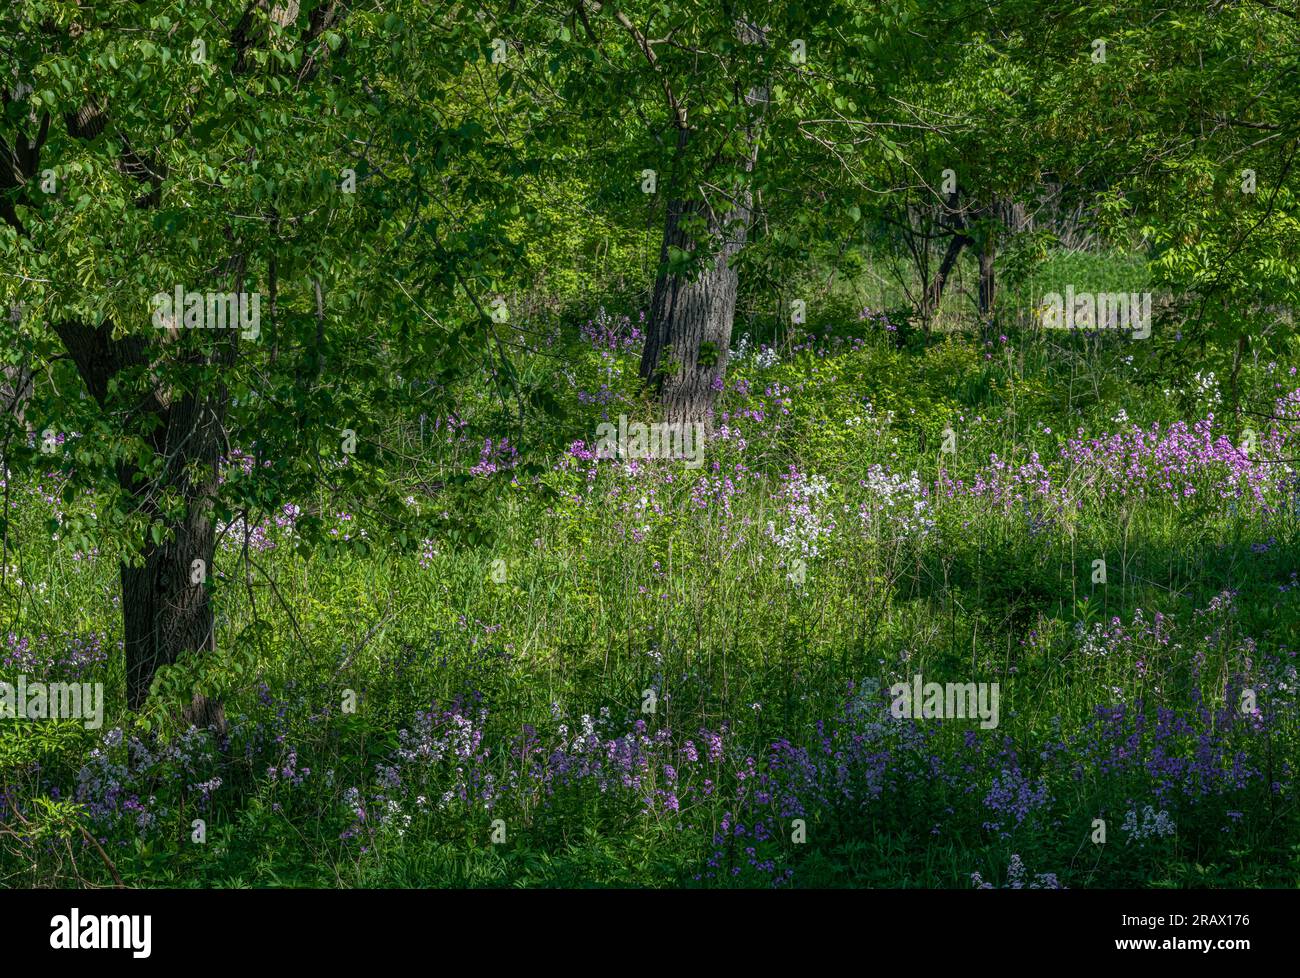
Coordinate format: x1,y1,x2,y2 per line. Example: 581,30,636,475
322,587,1300,888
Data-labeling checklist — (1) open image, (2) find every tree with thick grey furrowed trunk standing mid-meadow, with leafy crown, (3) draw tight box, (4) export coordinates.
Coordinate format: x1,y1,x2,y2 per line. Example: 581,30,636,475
495,0,967,421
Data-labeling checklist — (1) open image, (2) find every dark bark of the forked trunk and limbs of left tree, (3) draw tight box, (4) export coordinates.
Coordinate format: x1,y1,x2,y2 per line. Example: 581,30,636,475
0,11,339,728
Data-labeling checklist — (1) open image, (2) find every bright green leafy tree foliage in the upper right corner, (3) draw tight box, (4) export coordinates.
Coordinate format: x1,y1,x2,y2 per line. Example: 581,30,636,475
987,0,1300,408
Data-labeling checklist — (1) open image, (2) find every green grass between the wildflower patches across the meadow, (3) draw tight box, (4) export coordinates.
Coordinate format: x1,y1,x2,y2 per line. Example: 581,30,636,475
0,304,1300,887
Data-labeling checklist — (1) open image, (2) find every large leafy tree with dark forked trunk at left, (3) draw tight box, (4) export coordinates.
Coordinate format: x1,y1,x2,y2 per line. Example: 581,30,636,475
0,0,533,723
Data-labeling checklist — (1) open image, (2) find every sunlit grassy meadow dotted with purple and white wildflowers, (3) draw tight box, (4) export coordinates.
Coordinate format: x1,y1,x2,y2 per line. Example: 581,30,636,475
0,296,1300,888
